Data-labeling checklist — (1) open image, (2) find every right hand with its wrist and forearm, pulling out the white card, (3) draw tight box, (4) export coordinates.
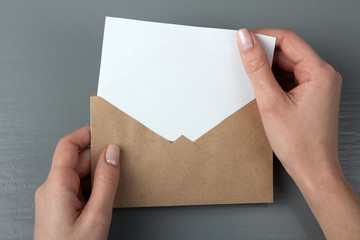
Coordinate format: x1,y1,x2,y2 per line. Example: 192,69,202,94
237,29,360,239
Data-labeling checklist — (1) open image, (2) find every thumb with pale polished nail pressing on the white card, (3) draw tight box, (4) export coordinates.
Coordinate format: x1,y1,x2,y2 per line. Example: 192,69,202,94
236,29,285,109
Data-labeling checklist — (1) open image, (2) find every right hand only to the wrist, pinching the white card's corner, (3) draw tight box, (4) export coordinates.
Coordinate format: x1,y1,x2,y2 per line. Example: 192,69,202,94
239,29,341,184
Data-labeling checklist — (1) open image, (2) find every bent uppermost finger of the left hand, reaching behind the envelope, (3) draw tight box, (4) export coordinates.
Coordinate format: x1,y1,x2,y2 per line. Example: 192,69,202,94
50,126,90,172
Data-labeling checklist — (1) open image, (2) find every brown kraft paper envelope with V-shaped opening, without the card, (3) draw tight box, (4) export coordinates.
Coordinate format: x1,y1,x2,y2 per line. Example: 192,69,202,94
91,96,273,207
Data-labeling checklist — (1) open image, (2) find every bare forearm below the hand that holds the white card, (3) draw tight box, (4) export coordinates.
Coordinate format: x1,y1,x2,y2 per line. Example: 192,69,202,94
293,159,360,239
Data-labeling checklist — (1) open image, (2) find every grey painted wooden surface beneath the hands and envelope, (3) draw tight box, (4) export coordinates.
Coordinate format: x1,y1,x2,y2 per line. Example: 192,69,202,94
0,0,360,239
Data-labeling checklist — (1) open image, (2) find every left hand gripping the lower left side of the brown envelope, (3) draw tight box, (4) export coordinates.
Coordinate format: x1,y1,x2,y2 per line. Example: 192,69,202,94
34,126,120,240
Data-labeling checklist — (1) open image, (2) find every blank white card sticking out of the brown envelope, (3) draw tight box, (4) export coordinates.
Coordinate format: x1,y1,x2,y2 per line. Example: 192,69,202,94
98,17,275,141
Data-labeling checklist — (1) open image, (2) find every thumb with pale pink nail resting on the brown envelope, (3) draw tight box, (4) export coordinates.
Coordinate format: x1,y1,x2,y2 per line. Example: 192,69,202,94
83,145,120,227
